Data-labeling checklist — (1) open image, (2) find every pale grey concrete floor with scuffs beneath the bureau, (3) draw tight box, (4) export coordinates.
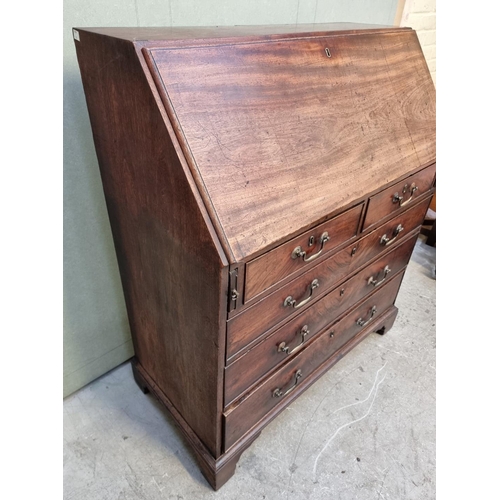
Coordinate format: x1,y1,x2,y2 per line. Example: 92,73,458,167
64,239,436,500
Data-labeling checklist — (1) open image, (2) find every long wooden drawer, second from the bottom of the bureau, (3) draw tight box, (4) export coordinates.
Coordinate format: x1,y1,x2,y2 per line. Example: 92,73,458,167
224,230,419,406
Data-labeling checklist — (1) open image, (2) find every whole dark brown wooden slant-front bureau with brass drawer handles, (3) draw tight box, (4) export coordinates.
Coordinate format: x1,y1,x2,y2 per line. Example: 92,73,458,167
74,24,435,489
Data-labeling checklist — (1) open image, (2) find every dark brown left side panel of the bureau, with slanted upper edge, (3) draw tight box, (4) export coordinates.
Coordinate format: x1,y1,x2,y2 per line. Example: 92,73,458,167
75,31,228,457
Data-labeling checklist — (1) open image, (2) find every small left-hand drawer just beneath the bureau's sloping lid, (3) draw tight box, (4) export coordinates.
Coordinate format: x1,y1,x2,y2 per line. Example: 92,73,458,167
244,204,363,303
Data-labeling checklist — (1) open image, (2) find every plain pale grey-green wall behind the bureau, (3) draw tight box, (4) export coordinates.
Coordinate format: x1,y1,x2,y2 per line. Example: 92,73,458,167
63,0,398,396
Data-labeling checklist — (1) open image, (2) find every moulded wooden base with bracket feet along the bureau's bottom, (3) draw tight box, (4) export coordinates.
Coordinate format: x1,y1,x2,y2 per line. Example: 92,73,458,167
132,306,398,490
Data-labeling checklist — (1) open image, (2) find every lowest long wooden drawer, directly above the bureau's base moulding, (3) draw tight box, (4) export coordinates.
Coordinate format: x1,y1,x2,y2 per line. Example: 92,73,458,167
224,271,404,450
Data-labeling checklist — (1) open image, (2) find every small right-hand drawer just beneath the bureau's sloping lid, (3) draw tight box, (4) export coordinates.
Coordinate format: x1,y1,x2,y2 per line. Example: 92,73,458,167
363,164,436,231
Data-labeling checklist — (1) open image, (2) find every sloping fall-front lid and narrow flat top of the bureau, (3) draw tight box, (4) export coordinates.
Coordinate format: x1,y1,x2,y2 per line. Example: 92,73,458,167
77,23,435,261
